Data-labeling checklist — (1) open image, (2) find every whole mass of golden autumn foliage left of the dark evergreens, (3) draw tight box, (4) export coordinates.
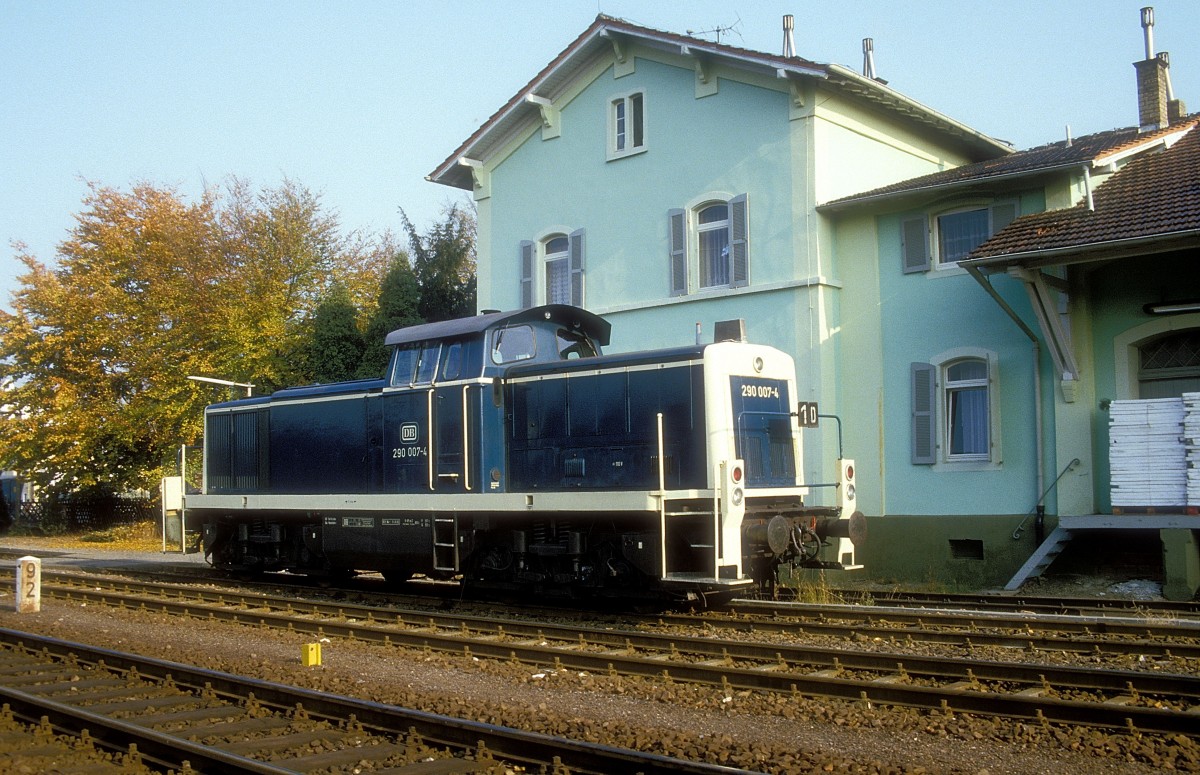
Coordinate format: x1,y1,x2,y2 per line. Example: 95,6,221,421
0,181,362,491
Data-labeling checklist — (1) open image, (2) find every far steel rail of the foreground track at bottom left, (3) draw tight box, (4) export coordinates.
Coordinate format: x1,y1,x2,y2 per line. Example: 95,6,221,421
0,629,745,775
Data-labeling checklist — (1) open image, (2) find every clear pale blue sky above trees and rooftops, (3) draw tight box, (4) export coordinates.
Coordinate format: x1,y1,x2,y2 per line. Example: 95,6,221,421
0,0,1200,308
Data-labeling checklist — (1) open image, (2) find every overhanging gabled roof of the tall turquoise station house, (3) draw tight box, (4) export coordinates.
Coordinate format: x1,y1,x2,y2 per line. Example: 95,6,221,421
427,14,1010,190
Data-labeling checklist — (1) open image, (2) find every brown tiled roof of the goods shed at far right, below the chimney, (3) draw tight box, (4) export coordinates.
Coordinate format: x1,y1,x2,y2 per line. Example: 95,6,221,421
971,119,1200,259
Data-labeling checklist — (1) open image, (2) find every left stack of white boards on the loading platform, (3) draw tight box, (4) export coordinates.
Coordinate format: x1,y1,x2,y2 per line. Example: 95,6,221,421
1109,398,1185,509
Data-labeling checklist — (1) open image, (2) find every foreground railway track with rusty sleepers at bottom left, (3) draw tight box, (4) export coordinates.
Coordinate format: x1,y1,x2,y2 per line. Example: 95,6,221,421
0,629,743,775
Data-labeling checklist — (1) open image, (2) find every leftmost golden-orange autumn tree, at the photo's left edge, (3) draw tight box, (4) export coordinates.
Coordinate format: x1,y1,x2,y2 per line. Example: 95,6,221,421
0,185,221,491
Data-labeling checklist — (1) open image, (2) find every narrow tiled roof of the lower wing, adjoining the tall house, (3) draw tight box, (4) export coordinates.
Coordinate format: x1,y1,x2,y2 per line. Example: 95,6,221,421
821,125,1195,208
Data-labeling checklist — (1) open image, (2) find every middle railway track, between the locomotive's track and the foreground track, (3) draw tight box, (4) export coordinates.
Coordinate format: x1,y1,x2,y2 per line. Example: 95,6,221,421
9,573,1200,737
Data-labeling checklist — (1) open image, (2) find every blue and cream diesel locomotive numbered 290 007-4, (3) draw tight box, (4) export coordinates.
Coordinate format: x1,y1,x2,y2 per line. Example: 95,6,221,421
186,305,865,601
